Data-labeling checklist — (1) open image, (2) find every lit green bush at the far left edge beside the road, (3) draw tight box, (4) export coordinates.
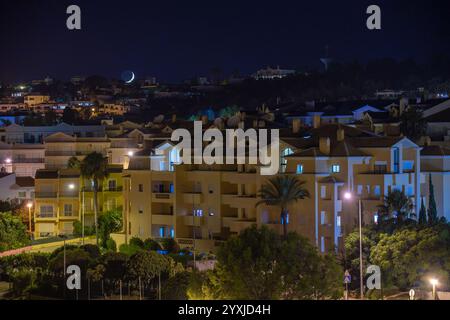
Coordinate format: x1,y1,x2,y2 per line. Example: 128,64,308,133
0,213,30,252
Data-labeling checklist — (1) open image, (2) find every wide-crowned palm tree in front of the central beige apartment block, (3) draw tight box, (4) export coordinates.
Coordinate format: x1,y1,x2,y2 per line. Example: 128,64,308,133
256,175,310,238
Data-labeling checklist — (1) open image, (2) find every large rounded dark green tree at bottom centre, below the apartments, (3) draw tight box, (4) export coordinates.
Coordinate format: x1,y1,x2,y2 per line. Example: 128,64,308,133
202,227,342,300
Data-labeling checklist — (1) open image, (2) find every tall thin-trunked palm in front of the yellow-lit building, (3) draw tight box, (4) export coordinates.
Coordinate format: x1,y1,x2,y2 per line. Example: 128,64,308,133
80,152,108,245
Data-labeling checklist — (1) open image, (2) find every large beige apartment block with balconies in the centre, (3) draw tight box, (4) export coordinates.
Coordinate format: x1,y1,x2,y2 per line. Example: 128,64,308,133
124,125,421,252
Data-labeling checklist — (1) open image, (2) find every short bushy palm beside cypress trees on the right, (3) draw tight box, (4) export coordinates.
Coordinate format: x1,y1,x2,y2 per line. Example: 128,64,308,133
378,190,414,223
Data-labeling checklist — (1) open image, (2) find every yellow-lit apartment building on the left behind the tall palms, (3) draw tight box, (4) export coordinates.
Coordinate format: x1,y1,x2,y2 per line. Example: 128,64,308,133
33,166,123,238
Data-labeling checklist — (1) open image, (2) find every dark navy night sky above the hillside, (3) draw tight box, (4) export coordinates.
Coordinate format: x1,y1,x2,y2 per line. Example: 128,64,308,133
0,0,450,82
